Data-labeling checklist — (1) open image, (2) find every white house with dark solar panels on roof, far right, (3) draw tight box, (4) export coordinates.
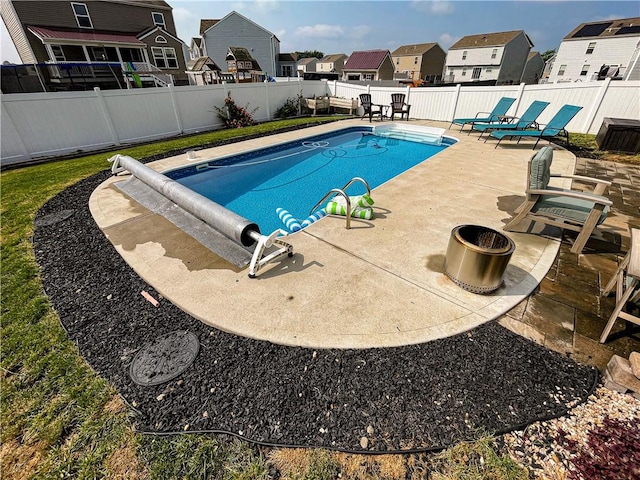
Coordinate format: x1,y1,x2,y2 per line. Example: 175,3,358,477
548,17,640,83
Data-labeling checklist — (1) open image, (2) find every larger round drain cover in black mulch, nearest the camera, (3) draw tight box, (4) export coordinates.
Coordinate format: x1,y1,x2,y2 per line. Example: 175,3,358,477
129,330,200,386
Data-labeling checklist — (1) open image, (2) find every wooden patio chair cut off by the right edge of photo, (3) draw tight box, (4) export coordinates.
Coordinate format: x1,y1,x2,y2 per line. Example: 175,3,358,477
600,228,640,343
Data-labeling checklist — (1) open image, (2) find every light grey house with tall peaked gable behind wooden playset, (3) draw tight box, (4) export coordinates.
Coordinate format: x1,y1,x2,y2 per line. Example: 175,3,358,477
200,11,280,76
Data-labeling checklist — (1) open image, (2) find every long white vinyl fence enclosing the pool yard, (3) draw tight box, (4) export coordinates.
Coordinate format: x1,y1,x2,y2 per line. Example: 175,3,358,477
0,79,640,166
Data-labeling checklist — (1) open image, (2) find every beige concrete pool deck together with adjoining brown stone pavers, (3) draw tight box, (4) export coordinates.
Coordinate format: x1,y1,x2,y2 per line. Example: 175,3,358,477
90,120,640,367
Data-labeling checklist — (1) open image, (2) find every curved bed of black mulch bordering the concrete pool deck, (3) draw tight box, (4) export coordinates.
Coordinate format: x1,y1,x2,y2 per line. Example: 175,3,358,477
34,167,597,452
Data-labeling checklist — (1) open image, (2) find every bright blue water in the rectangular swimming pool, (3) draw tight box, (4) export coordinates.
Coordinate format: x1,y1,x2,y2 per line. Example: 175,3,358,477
165,127,454,234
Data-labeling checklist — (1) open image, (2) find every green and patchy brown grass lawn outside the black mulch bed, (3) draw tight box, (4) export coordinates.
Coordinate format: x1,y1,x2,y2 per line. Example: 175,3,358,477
0,117,574,480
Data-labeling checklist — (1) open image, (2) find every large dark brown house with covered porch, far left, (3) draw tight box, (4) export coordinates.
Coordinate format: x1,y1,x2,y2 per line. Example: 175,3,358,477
0,0,189,90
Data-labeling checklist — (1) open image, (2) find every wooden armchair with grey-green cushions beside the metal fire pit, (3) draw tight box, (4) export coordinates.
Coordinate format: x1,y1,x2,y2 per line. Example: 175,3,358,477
503,146,612,253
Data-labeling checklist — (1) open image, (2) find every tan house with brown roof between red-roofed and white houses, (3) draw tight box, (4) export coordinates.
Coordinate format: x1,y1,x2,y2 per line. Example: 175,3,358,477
391,43,447,83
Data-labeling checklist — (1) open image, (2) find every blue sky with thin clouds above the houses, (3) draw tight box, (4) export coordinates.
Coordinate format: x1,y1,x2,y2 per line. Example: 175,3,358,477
0,0,640,63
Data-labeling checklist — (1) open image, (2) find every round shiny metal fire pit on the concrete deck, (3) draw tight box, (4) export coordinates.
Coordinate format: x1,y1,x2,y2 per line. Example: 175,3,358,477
444,225,516,293
